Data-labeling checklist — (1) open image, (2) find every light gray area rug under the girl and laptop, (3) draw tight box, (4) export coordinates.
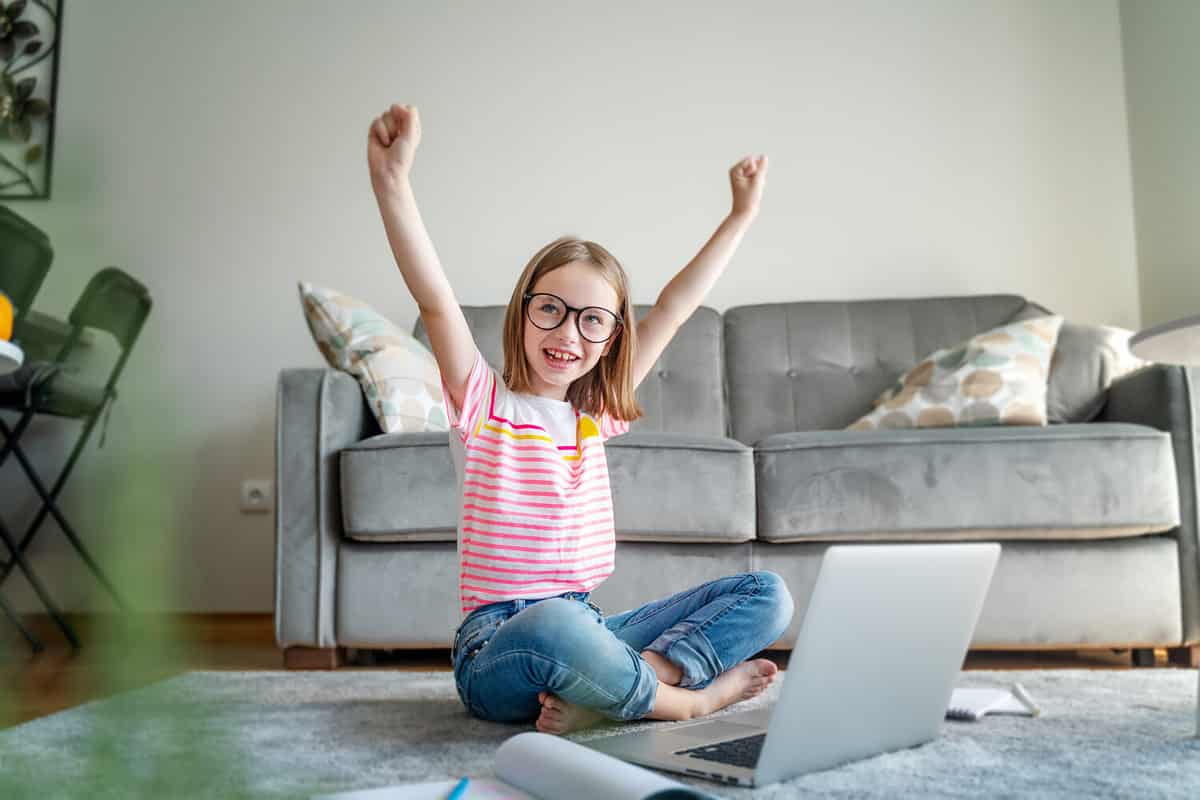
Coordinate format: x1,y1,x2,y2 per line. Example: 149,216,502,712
0,669,1200,799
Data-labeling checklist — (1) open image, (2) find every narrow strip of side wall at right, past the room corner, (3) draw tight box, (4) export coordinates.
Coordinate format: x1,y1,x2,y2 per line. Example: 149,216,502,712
1121,0,1200,325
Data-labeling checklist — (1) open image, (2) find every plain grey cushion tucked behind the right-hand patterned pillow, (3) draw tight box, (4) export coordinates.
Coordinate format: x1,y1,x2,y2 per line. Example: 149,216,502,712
1046,320,1150,422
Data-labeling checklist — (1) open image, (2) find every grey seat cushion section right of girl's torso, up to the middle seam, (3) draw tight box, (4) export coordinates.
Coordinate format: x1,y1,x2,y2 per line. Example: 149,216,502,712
605,432,755,542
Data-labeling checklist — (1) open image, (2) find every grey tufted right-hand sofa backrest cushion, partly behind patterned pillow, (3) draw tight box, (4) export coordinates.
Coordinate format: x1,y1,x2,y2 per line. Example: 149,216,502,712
724,295,1050,444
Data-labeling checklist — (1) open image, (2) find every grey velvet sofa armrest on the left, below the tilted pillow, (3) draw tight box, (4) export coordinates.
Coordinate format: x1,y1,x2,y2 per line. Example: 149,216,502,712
275,369,377,648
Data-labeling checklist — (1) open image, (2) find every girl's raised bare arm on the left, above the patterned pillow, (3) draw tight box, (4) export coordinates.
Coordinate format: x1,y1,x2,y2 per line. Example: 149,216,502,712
367,104,476,409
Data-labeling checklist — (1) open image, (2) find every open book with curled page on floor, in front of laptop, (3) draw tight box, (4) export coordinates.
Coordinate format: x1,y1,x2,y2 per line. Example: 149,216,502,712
313,732,715,800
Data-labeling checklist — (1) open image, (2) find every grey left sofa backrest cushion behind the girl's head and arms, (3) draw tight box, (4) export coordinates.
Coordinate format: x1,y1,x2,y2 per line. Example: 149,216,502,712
413,306,728,437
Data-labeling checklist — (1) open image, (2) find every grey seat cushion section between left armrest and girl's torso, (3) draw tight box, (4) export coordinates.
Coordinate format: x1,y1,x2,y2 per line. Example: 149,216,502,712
340,431,458,542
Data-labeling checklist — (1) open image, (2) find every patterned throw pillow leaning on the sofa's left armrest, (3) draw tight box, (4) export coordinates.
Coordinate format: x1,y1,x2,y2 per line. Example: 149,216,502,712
300,281,450,433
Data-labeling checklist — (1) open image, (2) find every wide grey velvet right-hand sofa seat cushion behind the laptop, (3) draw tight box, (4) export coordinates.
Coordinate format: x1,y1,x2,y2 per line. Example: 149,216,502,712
755,423,1180,542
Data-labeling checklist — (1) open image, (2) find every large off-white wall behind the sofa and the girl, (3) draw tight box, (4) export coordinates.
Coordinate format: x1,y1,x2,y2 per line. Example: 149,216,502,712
0,0,1139,610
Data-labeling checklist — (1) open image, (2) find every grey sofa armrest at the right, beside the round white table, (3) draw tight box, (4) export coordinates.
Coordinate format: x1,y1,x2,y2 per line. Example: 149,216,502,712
1100,363,1200,643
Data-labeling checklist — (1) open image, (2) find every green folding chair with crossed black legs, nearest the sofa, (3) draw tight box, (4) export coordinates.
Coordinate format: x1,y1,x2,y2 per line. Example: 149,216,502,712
0,266,151,646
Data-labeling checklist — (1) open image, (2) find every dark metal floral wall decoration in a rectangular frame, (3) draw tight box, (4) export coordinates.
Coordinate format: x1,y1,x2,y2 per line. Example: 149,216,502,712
0,0,64,200
